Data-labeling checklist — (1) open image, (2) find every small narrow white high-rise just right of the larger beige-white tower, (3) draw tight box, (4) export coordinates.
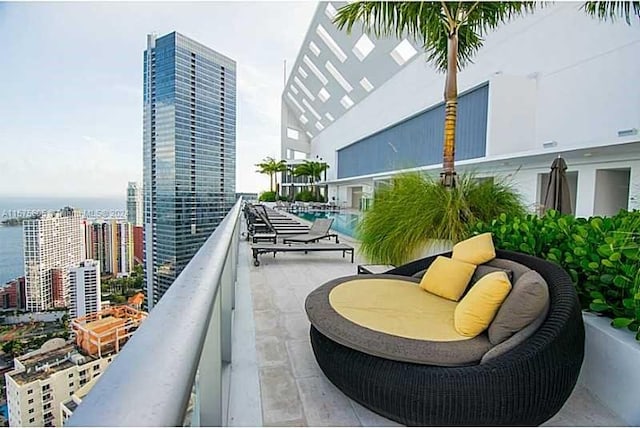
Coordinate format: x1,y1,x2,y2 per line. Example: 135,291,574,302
69,260,102,318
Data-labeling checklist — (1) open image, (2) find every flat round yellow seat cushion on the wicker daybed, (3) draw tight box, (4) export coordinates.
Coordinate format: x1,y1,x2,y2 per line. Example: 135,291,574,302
329,278,471,342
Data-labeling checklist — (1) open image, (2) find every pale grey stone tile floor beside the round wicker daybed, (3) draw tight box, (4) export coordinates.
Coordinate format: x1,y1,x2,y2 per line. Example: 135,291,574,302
229,224,624,426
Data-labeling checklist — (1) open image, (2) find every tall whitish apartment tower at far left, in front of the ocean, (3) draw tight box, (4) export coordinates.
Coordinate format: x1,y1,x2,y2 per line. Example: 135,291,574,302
23,207,85,311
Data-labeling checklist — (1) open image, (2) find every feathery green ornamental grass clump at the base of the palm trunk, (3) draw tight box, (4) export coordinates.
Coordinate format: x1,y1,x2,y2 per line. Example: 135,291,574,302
357,173,525,265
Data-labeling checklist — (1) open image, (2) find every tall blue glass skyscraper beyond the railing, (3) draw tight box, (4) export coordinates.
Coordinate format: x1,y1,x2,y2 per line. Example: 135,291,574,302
143,32,236,310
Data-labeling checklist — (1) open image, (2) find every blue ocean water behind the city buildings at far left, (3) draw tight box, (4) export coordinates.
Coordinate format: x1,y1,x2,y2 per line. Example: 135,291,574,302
0,195,126,284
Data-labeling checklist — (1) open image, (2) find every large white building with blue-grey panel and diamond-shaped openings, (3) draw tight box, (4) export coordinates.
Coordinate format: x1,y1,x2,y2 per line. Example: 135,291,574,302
281,2,640,216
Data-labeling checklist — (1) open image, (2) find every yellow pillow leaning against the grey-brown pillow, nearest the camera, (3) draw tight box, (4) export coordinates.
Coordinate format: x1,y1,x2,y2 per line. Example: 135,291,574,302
454,272,511,337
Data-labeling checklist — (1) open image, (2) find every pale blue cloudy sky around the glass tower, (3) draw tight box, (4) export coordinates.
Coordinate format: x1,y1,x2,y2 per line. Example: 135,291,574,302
0,1,317,197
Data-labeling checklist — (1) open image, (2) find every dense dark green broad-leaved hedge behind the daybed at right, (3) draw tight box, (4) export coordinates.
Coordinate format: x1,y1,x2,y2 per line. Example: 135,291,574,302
475,210,640,340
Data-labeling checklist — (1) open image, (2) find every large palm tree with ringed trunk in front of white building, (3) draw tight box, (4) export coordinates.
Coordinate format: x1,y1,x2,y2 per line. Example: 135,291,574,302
334,1,535,187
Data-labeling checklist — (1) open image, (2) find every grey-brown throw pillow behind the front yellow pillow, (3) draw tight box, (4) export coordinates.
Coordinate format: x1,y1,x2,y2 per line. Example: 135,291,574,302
488,270,549,345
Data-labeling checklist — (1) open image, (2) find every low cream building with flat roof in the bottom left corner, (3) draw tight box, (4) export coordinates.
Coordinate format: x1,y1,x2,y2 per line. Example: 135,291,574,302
5,339,115,427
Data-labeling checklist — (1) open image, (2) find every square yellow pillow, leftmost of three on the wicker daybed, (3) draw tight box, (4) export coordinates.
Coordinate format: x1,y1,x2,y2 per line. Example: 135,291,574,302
420,256,476,302
